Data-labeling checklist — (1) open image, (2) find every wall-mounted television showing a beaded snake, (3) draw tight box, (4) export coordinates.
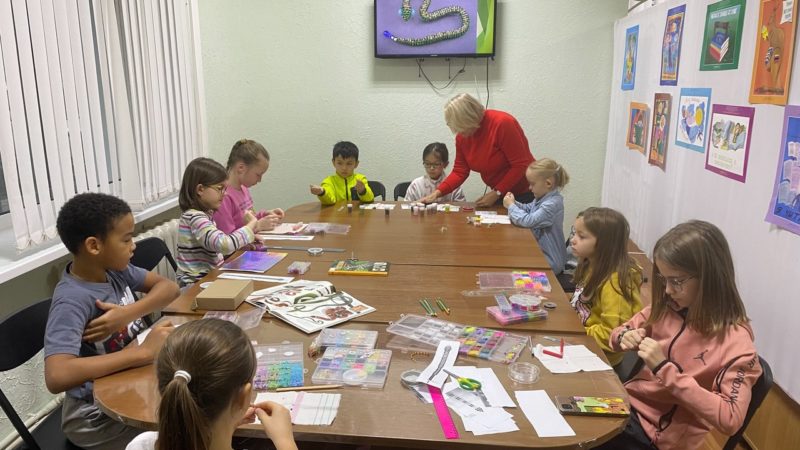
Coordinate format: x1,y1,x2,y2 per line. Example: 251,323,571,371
375,0,497,58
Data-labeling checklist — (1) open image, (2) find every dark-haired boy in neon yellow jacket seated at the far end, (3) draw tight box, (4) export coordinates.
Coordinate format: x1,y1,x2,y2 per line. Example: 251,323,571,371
309,141,375,205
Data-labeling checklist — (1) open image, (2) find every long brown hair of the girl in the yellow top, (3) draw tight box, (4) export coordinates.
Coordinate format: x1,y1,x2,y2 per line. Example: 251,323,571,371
574,208,642,303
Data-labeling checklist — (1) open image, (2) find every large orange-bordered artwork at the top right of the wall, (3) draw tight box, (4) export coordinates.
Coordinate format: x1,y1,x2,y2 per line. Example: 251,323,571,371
750,0,797,105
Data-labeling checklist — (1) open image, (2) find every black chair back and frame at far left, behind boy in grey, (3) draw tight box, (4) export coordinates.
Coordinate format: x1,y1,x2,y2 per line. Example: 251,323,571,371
0,298,52,450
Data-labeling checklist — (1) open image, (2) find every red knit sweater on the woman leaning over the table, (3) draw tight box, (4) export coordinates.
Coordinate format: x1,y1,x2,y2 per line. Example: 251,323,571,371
438,109,534,195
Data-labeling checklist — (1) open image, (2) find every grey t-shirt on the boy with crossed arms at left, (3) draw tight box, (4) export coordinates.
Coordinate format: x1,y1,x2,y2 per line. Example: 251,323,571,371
44,263,147,402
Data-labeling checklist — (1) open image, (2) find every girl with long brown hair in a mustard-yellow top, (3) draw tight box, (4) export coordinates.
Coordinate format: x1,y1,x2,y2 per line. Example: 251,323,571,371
570,208,642,366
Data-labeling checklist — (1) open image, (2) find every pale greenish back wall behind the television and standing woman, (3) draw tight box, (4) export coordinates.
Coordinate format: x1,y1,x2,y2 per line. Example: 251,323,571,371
200,0,627,229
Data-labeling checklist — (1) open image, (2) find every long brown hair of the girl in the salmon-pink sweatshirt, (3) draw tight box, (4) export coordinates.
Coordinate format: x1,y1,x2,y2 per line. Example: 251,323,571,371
648,220,750,336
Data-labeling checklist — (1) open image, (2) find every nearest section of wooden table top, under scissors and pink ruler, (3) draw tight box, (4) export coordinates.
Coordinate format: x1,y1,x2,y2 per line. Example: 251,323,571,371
94,316,626,449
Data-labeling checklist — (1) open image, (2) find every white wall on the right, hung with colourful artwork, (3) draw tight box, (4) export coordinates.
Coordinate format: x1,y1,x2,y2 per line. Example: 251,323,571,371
603,0,800,401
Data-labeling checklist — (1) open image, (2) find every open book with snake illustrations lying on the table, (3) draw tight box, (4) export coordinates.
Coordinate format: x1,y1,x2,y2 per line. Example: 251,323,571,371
247,280,375,333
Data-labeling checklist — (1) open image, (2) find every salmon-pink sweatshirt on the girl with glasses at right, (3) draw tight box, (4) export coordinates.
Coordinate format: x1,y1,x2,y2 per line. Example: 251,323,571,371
609,305,761,450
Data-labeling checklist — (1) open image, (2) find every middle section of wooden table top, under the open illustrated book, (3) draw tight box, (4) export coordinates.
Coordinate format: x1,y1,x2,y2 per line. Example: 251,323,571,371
163,256,585,333
